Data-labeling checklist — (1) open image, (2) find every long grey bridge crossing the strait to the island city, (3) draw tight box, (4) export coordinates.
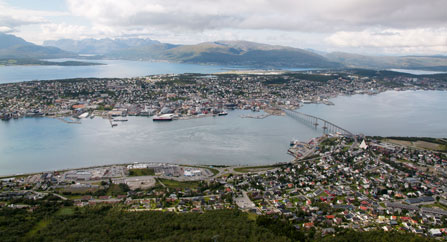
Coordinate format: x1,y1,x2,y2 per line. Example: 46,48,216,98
283,109,354,137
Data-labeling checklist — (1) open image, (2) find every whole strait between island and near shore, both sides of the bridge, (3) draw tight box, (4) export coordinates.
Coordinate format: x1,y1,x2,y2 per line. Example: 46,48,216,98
0,91,447,175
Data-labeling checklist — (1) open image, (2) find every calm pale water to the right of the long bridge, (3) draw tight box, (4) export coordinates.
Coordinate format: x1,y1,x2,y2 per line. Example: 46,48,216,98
300,91,447,138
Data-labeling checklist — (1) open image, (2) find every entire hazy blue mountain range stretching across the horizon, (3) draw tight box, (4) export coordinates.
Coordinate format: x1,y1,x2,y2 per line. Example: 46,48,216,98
0,33,447,71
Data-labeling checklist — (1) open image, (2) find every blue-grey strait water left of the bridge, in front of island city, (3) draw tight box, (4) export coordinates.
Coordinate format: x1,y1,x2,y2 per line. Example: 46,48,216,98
0,110,320,175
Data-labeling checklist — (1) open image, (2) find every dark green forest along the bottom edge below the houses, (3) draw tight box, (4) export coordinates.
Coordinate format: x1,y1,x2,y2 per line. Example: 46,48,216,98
0,197,430,241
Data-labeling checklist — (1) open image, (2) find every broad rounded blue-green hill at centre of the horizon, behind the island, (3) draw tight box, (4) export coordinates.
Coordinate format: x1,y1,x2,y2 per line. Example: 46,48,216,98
106,41,341,68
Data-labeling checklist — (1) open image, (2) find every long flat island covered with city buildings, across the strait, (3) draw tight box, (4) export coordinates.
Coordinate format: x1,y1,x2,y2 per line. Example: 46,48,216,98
0,69,447,123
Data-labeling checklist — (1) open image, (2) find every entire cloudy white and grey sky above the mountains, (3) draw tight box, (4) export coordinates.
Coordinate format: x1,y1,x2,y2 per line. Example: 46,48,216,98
0,0,447,55
